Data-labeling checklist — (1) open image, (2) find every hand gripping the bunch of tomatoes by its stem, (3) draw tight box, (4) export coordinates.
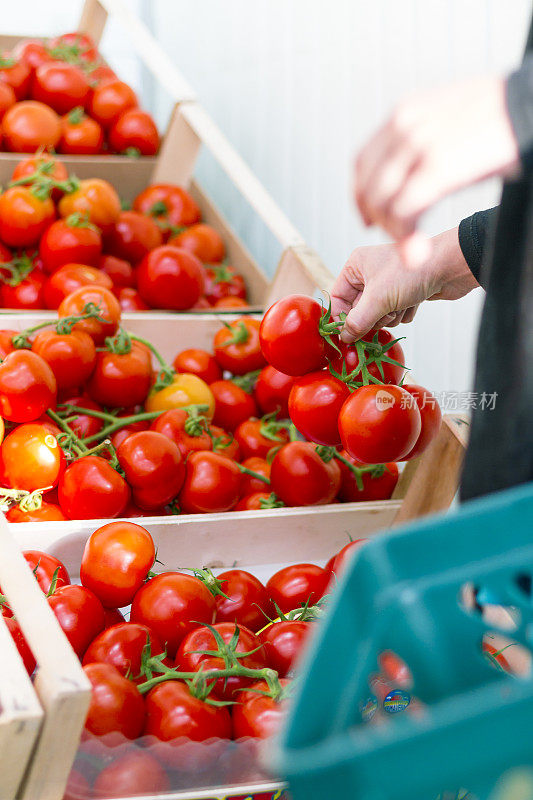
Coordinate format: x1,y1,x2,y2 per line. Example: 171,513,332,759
331,223,479,342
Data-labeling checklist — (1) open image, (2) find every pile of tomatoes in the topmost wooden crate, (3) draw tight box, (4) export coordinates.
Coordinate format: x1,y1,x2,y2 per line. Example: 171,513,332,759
0,33,159,156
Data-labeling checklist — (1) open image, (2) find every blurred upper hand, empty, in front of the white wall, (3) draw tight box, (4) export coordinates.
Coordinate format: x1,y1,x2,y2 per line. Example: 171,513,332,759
355,78,519,266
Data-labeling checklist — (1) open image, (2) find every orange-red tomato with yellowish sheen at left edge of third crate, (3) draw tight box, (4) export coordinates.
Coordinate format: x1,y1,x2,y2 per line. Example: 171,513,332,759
0,422,65,492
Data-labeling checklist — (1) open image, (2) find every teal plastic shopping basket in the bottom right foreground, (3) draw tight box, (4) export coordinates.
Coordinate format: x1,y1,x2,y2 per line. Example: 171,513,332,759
270,484,533,800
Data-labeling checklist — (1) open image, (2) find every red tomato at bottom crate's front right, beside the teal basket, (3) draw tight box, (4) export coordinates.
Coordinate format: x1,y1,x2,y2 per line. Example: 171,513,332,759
232,679,290,739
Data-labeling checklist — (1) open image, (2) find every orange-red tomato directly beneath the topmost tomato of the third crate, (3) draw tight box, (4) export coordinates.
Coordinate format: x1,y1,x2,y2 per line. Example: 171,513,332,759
31,330,96,391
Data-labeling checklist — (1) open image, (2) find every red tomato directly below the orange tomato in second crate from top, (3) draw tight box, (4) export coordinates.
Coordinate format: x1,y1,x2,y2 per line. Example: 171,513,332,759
39,214,102,272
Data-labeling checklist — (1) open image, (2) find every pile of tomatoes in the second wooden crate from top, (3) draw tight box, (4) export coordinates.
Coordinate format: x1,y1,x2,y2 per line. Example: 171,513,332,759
0,153,248,311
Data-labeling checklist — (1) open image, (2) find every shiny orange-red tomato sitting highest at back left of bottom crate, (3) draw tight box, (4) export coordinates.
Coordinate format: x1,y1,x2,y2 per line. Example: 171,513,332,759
80,522,155,608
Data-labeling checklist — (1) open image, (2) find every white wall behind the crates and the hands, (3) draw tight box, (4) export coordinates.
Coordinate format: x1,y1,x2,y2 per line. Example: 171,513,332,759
2,0,530,391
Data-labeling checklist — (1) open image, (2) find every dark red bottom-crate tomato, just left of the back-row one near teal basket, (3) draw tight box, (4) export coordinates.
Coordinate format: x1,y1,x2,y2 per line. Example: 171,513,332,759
215,569,273,633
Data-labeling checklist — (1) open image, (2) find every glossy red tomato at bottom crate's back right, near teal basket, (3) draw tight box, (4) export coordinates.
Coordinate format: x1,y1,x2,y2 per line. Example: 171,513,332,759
266,564,329,614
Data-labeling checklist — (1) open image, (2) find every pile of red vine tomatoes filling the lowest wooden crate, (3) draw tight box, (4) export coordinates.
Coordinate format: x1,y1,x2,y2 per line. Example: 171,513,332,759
2,522,364,796
